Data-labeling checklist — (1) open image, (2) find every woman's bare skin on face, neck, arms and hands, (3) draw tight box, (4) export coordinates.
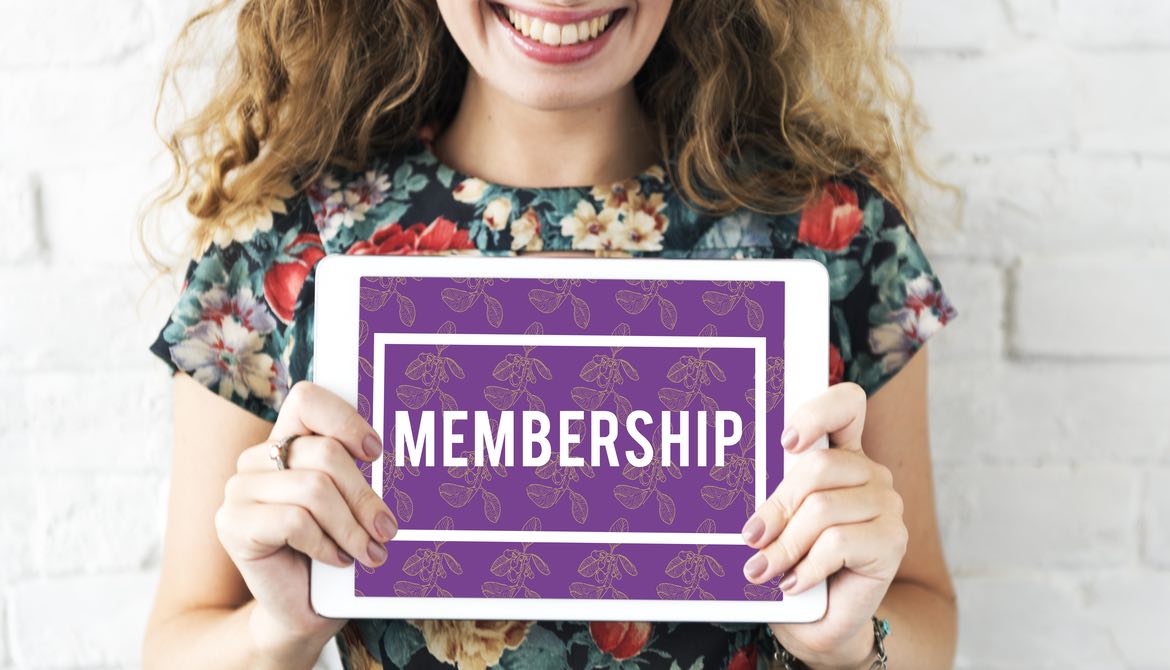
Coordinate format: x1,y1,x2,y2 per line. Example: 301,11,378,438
143,0,956,669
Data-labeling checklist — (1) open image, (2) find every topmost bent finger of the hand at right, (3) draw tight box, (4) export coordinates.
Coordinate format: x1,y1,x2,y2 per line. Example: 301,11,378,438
780,381,867,454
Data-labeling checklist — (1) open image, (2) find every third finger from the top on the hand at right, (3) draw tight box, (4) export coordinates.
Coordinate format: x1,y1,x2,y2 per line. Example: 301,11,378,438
743,486,892,583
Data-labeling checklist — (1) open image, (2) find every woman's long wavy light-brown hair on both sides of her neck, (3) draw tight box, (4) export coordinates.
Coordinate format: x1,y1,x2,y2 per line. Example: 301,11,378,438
138,0,940,666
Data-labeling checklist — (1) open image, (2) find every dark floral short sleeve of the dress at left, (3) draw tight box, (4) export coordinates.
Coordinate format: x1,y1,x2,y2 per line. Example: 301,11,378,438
150,190,325,421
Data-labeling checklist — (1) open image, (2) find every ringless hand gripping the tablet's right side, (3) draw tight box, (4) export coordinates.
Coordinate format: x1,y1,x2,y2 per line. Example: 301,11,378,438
743,382,908,668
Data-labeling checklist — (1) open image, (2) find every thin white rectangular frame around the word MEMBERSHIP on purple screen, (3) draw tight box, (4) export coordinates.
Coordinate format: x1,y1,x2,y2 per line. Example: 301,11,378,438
370,332,768,545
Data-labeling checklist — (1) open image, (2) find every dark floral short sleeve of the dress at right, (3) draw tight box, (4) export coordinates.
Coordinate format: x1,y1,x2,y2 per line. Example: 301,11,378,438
792,177,958,395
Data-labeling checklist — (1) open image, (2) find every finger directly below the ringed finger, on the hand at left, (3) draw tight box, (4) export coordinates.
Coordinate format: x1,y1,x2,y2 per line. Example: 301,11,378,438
225,470,386,567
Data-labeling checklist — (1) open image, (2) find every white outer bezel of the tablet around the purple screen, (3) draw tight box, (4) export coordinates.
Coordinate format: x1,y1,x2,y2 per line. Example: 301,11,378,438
310,255,828,623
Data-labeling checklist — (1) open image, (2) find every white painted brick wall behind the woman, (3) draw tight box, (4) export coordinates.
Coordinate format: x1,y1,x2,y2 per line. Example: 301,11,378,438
0,0,1170,670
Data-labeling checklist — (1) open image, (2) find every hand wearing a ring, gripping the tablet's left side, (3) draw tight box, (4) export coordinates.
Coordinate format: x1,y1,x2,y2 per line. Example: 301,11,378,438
215,381,398,651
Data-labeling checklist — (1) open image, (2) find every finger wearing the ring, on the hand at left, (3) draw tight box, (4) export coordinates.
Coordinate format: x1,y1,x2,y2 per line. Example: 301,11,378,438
236,435,398,543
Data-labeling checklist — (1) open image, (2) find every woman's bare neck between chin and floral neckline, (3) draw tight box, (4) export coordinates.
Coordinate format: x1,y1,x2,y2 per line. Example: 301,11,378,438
433,70,659,188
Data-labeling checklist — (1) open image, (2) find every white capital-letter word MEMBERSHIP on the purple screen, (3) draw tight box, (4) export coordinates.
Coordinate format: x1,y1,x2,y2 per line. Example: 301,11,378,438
393,409,743,468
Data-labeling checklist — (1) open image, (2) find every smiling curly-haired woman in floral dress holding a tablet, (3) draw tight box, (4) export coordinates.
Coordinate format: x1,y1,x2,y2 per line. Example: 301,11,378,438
144,0,956,669
